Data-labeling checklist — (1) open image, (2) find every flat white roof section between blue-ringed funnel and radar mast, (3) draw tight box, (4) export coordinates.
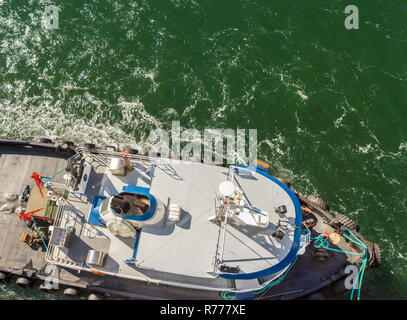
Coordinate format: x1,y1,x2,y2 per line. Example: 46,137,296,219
137,163,227,277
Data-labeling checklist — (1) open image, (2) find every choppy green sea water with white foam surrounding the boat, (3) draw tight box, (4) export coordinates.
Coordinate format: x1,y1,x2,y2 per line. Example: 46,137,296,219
0,0,407,299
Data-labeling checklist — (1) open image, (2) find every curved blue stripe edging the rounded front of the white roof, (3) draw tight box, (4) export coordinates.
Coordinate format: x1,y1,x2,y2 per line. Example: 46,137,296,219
220,165,302,280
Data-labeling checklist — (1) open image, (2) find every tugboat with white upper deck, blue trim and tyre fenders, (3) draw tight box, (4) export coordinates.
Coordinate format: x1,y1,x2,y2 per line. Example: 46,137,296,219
0,137,381,300
